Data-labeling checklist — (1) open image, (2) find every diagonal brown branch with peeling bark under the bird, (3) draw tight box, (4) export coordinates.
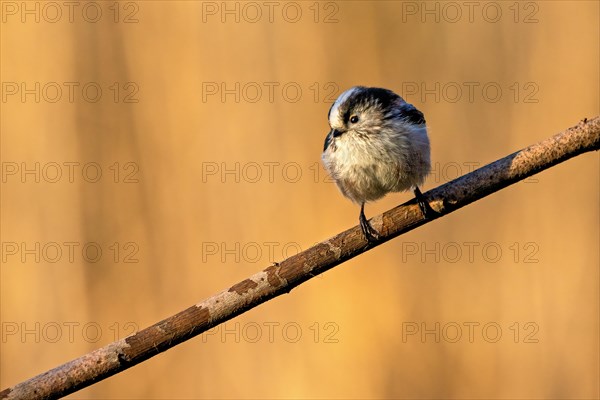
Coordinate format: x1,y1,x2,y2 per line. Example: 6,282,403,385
0,117,600,399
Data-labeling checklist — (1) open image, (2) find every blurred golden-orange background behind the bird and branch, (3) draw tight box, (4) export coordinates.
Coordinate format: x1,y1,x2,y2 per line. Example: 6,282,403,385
0,1,600,399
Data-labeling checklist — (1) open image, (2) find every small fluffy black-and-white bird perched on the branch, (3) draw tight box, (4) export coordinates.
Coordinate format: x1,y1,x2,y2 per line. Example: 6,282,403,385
322,86,436,242
